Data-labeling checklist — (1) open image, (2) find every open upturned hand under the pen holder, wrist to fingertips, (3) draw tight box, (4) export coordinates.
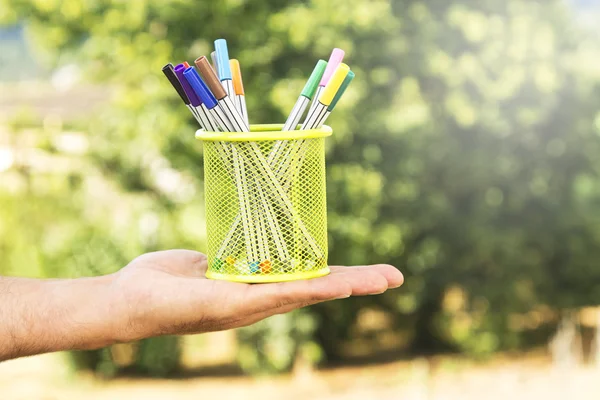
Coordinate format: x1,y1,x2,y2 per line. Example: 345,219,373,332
111,250,403,341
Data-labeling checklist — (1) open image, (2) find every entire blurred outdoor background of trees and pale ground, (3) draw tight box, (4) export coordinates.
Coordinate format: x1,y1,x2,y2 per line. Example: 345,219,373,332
0,0,600,400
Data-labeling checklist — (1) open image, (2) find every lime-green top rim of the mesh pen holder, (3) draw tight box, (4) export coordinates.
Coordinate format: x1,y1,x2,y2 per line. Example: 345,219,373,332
196,124,333,142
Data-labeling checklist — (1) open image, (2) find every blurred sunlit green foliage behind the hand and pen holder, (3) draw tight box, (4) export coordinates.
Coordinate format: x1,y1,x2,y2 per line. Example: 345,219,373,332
0,0,600,373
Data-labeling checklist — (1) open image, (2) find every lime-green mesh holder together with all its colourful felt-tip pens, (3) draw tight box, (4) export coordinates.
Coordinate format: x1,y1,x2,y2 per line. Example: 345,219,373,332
163,39,354,282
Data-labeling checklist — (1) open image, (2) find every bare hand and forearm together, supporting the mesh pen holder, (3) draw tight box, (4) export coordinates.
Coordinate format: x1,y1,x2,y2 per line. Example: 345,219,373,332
0,250,403,361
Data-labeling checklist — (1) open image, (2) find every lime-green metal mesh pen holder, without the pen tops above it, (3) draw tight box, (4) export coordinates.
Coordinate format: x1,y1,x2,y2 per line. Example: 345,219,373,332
196,125,332,282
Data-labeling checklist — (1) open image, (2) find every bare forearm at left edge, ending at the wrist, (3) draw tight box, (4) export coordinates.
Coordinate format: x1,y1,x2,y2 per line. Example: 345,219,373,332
0,276,120,361
